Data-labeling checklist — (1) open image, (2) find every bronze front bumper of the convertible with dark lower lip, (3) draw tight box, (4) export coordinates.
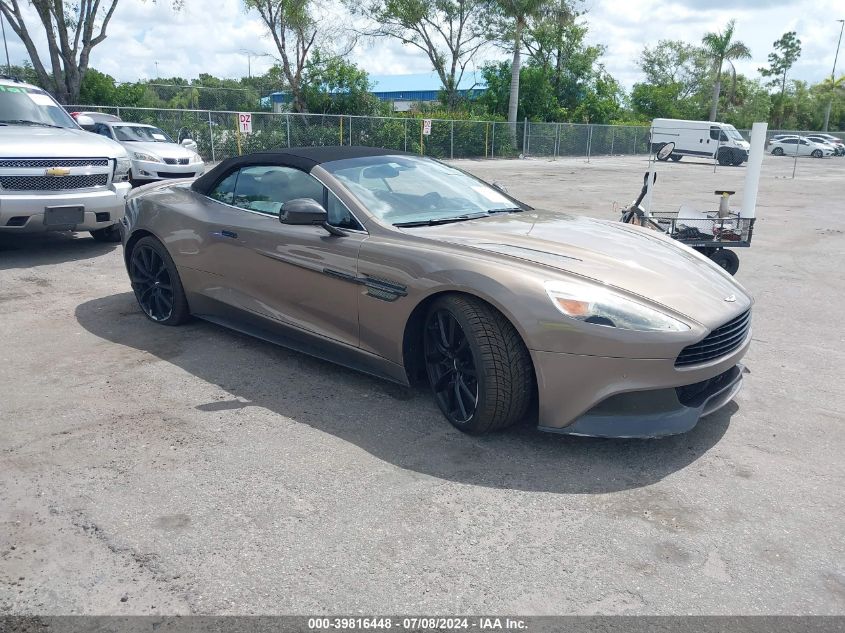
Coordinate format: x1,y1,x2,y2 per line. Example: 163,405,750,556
531,333,751,437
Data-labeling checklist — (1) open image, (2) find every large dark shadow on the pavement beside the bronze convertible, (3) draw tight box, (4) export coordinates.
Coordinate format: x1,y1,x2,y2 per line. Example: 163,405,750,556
76,292,738,494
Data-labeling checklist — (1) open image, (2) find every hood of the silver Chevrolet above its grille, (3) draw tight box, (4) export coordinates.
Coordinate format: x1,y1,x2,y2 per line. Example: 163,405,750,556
0,125,126,158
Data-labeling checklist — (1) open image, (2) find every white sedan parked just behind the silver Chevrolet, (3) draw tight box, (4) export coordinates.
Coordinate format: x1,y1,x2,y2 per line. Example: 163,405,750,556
94,122,205,185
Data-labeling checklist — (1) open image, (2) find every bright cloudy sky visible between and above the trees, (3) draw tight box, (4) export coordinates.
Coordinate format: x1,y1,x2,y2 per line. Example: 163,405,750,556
0,0,845,89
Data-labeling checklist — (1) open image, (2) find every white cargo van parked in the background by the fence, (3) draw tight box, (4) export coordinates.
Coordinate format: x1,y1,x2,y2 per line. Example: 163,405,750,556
651,119,751,165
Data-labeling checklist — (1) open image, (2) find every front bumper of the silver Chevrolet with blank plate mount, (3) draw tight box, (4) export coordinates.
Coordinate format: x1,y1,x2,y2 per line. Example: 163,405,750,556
0,182,131,233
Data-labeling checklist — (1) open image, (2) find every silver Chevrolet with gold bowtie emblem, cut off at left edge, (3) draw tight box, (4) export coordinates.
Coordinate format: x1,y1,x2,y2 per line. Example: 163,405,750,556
0,77,130,241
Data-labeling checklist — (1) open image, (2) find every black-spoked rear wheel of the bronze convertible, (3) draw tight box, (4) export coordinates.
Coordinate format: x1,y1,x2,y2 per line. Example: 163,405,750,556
129,236,190,325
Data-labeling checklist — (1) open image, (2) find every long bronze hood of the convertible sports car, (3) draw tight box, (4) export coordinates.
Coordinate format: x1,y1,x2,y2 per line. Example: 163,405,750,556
409,212,752,327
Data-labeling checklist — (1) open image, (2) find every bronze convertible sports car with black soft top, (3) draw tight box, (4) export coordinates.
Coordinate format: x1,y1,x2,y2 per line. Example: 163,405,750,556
121,147,752,437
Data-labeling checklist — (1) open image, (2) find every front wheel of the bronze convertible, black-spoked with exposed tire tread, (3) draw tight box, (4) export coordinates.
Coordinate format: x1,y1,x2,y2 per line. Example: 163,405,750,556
423,295,534,434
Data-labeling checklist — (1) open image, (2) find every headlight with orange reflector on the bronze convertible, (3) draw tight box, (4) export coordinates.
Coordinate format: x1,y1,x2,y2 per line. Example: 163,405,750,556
544,281,690,332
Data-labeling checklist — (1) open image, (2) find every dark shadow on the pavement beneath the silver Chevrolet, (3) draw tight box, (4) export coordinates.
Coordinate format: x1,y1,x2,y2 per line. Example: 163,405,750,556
0,232,120,270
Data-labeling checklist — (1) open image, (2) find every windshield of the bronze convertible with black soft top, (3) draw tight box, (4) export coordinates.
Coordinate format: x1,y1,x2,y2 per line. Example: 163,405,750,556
323,156,522,226
